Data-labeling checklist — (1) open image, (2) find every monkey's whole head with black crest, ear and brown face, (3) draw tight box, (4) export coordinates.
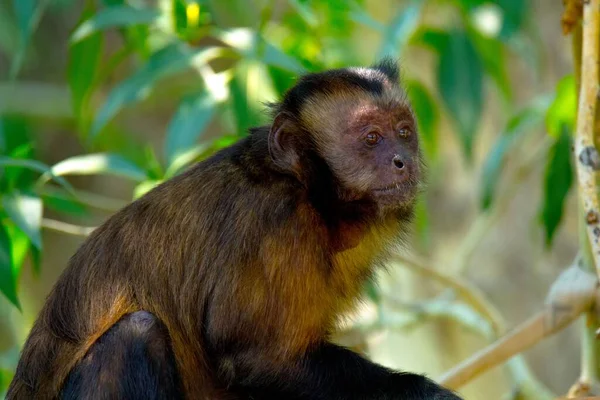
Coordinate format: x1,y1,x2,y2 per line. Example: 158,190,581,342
269,60,421,216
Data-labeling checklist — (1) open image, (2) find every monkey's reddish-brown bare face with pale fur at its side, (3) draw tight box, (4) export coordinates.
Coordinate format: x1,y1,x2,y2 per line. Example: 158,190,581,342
312,96,421,211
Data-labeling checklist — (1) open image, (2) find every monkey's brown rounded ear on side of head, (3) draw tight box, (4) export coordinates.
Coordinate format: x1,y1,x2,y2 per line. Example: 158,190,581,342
269,112,300,175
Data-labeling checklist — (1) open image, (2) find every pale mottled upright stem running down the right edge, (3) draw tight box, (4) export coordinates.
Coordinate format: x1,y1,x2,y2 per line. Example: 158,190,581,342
575,0,600,276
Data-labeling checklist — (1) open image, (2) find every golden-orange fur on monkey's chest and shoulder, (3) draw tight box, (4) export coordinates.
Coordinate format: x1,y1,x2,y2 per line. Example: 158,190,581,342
236,208,399,359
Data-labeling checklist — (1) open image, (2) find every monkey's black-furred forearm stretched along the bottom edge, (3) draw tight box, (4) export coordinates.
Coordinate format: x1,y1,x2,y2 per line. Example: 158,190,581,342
223,343,460,400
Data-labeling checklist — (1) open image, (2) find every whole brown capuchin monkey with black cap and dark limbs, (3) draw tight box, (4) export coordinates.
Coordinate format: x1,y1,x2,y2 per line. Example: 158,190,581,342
8,59,460,400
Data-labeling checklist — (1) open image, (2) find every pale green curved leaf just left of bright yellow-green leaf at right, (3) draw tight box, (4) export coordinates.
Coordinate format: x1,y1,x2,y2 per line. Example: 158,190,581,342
481,97,550,210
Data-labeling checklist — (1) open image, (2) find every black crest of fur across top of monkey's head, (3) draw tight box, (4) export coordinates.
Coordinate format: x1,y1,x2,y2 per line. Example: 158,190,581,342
266,57,400,118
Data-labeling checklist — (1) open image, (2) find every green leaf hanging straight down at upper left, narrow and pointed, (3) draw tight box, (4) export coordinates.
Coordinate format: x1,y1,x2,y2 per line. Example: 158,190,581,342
67,2,103,119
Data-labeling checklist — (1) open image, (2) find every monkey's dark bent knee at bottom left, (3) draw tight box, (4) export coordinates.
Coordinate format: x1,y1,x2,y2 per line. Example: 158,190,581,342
61,311,181,400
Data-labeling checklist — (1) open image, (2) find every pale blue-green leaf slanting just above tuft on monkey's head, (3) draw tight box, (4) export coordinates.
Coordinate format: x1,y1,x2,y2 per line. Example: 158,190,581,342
379,2,421,58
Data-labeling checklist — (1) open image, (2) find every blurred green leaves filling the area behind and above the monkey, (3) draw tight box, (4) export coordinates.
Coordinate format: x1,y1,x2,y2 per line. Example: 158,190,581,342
0,0,576,393
